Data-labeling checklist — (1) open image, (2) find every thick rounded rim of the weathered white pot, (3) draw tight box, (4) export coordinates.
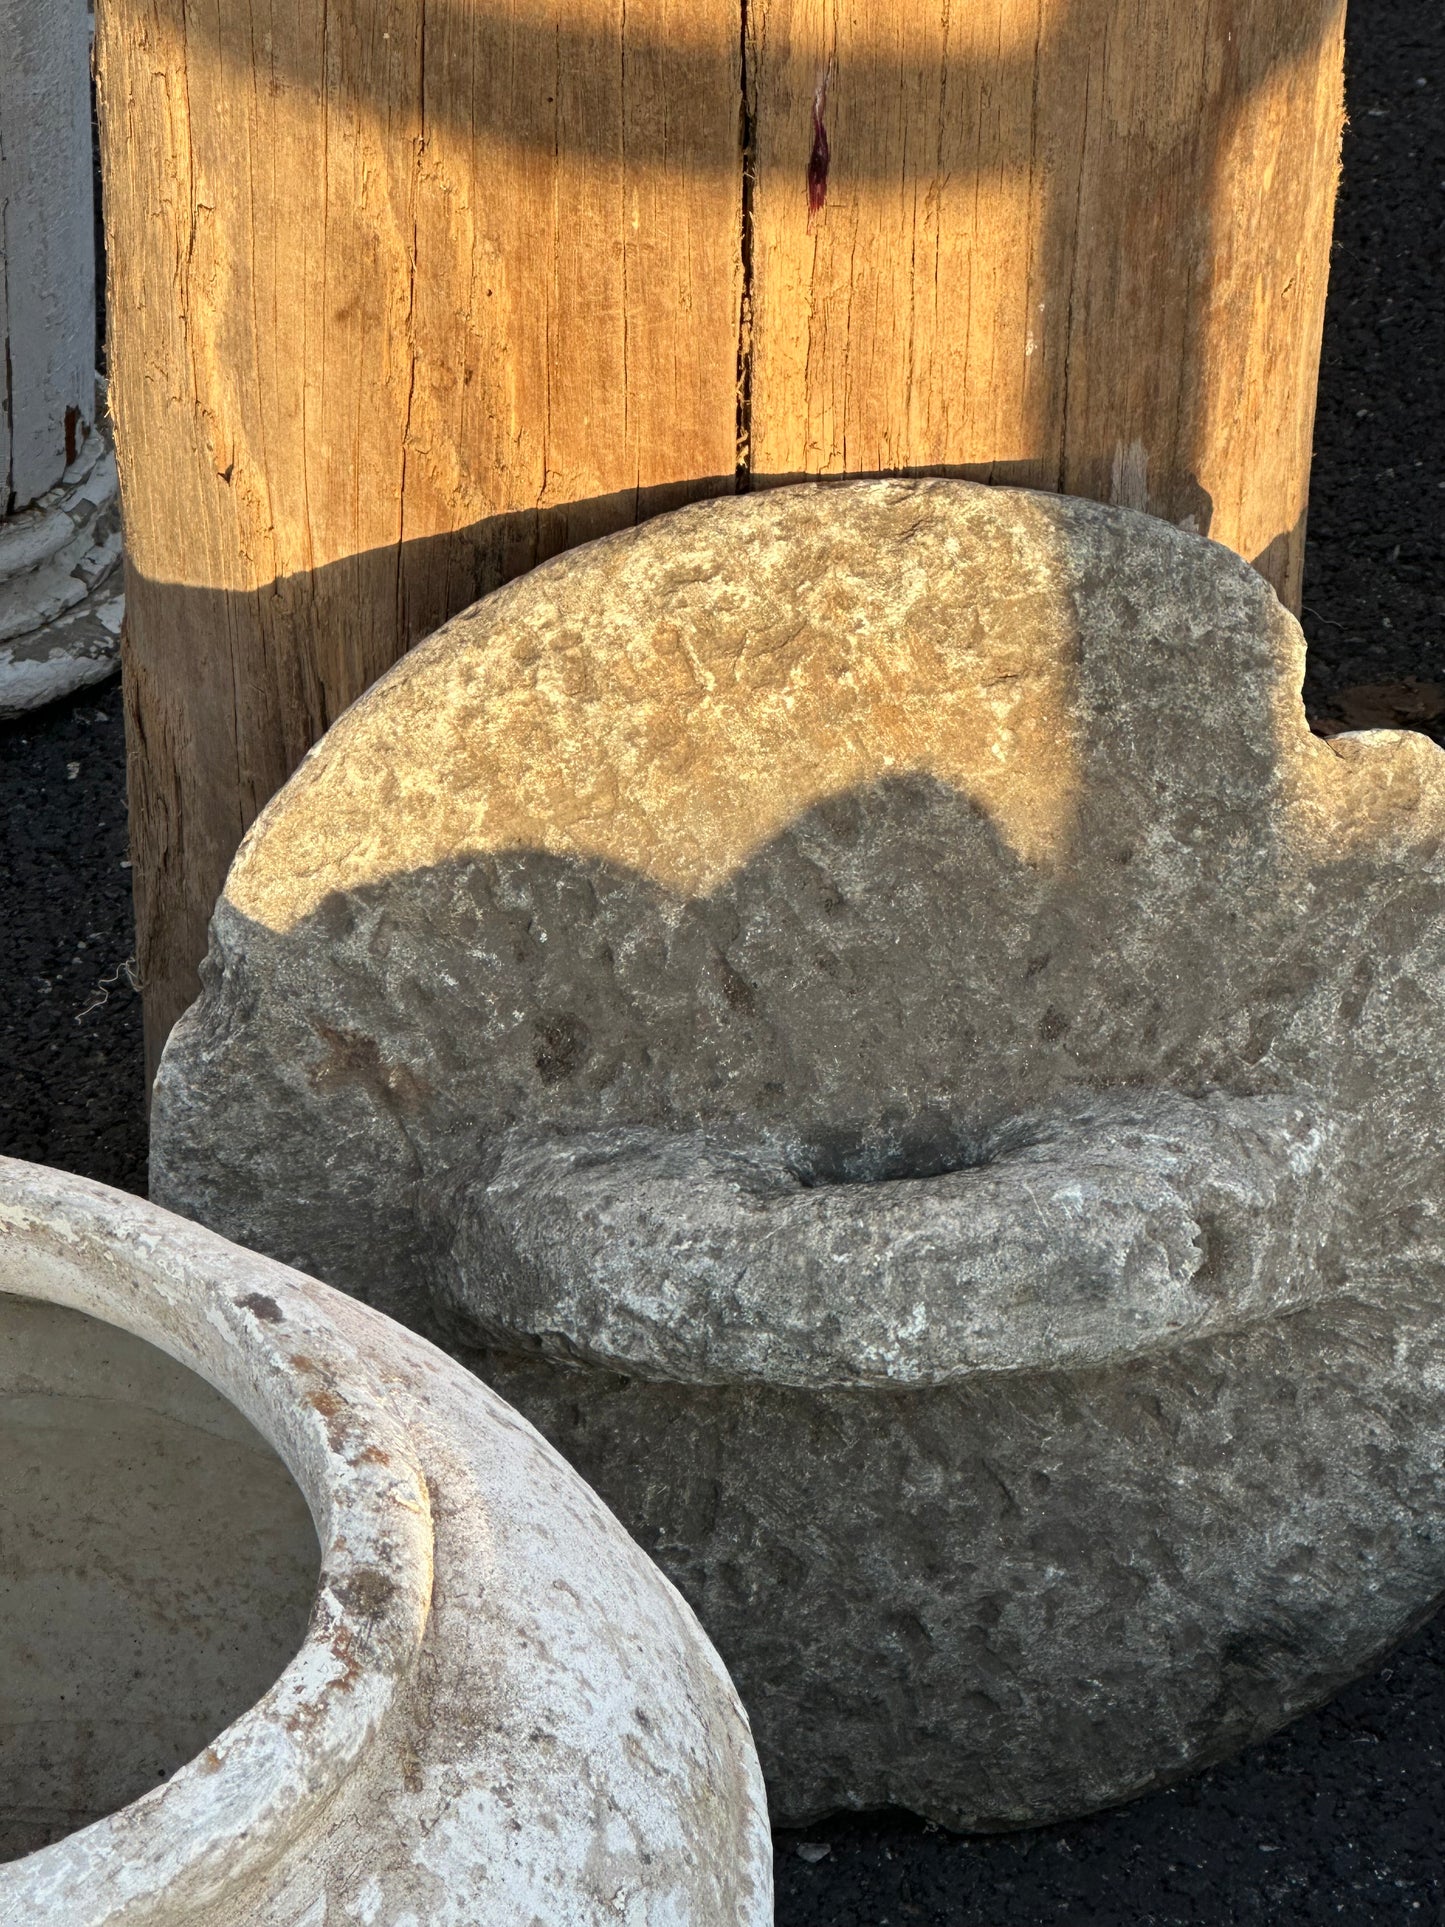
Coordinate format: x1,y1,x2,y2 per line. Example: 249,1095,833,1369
0,1158,434,1927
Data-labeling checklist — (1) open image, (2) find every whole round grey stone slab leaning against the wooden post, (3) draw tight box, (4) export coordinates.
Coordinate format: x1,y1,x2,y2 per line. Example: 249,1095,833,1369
152,482,1445,1827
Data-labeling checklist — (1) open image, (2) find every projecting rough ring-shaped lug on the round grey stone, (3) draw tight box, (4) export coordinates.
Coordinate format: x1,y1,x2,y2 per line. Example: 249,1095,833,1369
455,1091,1326,1387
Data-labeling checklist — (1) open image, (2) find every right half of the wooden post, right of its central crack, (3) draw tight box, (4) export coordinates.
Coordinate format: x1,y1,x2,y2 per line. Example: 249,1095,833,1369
748,0,1343,605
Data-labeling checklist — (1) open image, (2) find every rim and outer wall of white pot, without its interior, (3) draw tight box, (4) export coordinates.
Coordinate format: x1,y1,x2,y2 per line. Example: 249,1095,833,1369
0,1160,771,1927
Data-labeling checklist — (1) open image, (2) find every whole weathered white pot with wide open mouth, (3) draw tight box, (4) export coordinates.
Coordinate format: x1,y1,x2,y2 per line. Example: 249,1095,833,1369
0,1160,773,1927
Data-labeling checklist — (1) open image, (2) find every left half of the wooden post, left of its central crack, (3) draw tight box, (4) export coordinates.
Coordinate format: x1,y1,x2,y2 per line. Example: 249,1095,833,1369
100,0,742,1064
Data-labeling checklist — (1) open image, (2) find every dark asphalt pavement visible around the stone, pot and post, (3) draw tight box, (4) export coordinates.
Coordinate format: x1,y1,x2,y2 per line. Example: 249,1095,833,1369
0,0,1445,1927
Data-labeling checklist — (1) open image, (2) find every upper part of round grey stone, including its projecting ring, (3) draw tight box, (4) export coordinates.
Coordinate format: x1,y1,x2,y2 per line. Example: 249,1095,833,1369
152,480,1445,1387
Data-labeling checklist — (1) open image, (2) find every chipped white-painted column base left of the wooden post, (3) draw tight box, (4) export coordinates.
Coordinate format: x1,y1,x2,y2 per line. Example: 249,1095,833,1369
0,424,125,721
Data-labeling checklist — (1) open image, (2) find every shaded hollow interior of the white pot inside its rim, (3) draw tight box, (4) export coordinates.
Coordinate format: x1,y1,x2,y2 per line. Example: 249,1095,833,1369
0,1293,320,1860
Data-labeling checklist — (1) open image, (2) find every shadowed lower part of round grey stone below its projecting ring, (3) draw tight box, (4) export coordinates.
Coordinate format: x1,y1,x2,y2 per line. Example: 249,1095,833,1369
470,1305,1445,1831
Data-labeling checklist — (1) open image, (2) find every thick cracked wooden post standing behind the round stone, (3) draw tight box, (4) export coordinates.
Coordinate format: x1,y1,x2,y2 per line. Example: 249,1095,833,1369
100,0,1343,1064
